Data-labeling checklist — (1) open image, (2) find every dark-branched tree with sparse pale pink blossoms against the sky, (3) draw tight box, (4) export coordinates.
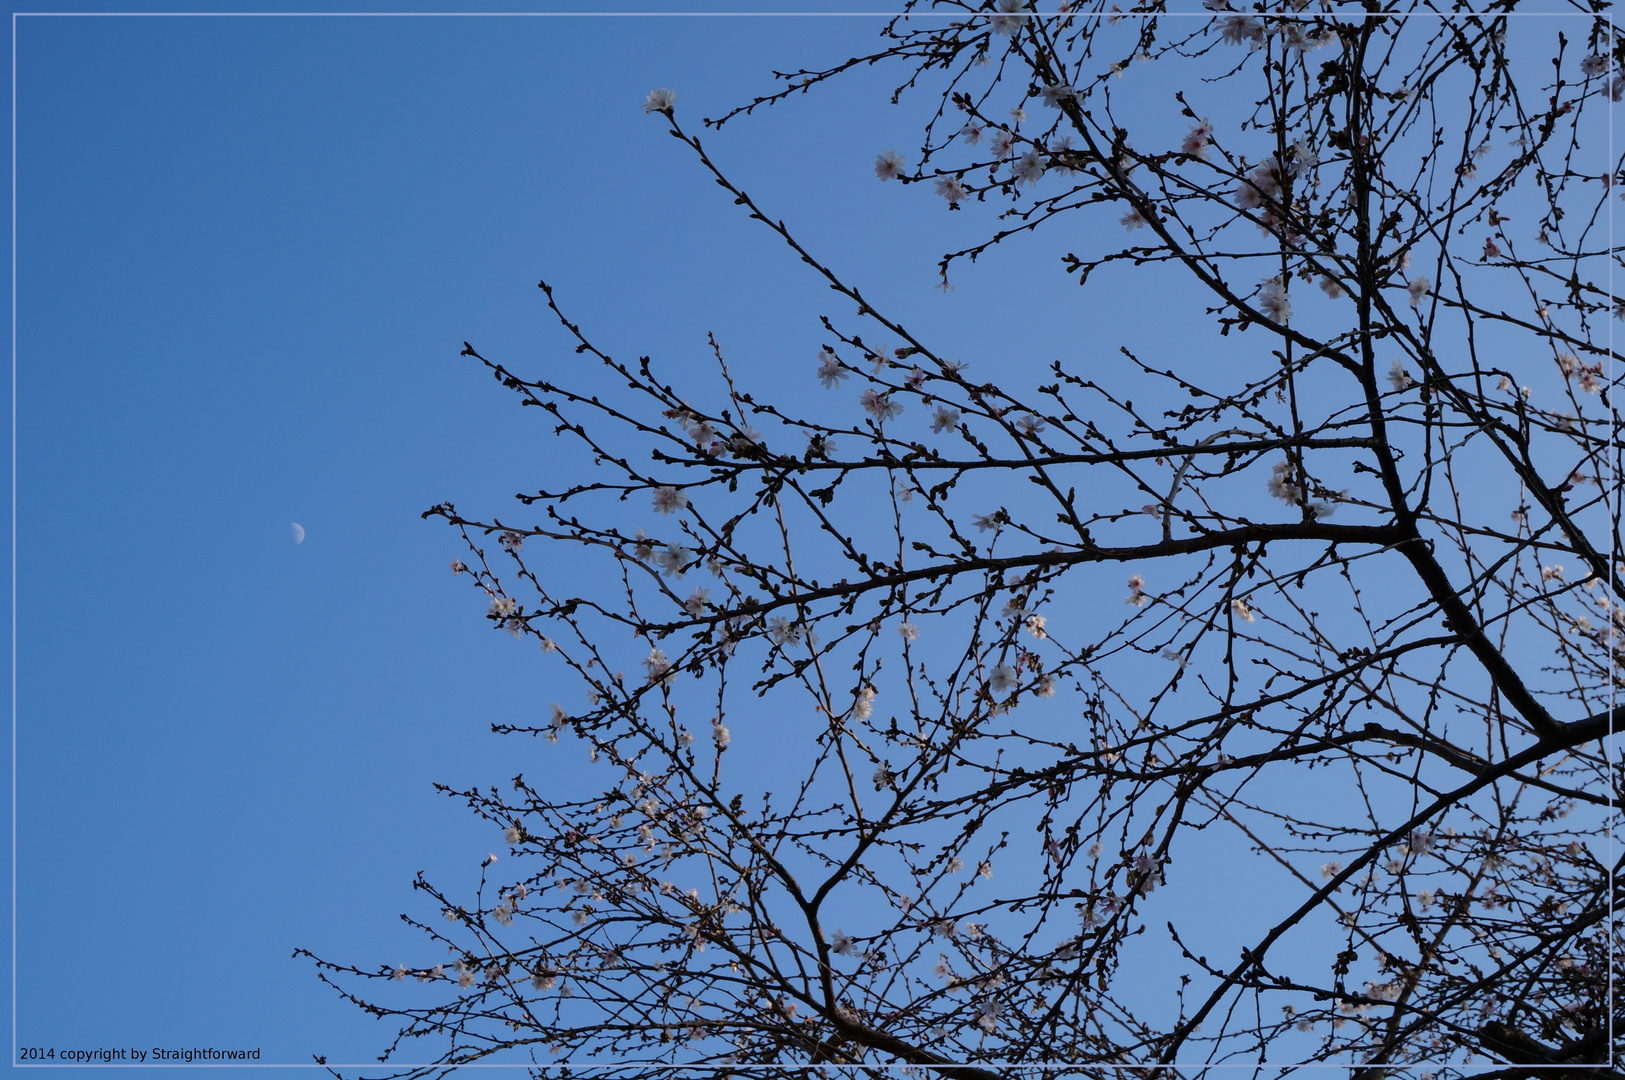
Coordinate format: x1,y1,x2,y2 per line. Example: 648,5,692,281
302,0,1625,1077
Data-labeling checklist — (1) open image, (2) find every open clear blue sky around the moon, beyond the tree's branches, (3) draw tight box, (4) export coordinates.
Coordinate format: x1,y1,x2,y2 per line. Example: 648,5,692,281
15,3,1605,1075
